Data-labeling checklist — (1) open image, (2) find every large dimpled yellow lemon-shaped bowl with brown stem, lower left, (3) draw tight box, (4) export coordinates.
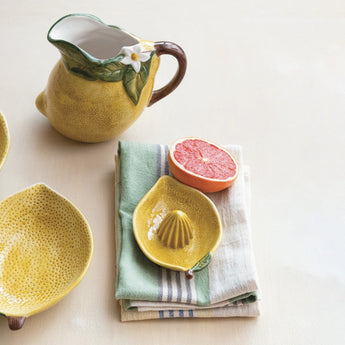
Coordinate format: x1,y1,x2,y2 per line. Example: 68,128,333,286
0,184,93,329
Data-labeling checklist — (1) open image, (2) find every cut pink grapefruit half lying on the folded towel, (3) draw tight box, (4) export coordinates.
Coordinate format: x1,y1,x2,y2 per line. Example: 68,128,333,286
168,138,238,193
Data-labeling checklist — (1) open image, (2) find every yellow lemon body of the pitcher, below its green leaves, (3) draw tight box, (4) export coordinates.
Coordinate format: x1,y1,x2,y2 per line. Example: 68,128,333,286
36,55,159,143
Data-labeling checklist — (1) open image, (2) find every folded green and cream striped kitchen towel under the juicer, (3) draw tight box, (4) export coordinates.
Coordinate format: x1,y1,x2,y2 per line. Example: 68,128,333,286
116,141,259,321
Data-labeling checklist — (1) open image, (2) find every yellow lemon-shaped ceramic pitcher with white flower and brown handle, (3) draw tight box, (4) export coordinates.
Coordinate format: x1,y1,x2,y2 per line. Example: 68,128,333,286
36,14,187,142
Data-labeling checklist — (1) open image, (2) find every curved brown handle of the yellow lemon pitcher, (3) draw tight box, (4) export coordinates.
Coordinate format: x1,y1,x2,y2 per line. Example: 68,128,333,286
148,41,187,107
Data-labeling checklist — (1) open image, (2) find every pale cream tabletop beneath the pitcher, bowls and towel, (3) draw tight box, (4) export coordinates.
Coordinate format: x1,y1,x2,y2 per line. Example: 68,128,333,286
0,0,345,345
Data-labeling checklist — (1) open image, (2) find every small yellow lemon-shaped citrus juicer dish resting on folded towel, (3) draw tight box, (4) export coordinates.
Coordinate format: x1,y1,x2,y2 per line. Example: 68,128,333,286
133,176,222,279
